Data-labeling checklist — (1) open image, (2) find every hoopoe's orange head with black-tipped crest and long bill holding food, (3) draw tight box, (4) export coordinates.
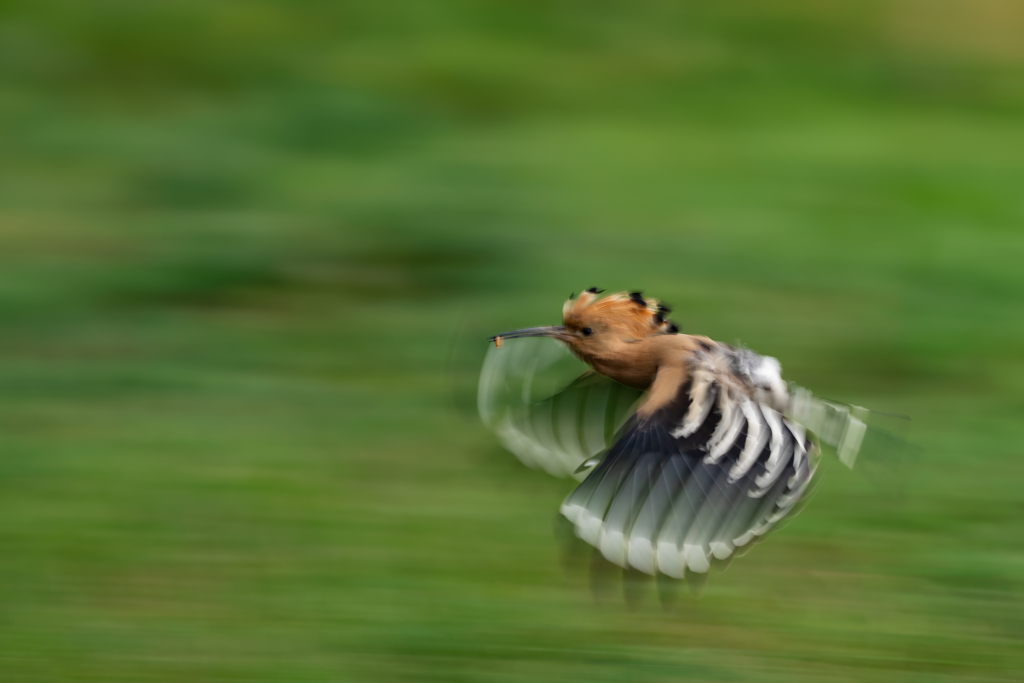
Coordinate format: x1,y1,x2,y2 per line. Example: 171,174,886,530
490,287,679,361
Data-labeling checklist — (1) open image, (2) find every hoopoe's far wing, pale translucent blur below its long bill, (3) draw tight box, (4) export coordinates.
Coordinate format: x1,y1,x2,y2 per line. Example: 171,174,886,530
477,338,641,479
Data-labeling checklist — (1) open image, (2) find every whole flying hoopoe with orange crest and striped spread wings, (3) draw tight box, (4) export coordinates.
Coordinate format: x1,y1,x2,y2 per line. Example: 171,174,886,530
478,288,866,579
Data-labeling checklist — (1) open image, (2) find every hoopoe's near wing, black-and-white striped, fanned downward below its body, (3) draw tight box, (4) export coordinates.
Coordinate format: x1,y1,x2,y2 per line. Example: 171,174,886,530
561,376,817,579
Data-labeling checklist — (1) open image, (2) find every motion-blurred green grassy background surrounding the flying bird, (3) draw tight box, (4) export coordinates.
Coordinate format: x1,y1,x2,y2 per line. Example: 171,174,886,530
0,0,1024,682
